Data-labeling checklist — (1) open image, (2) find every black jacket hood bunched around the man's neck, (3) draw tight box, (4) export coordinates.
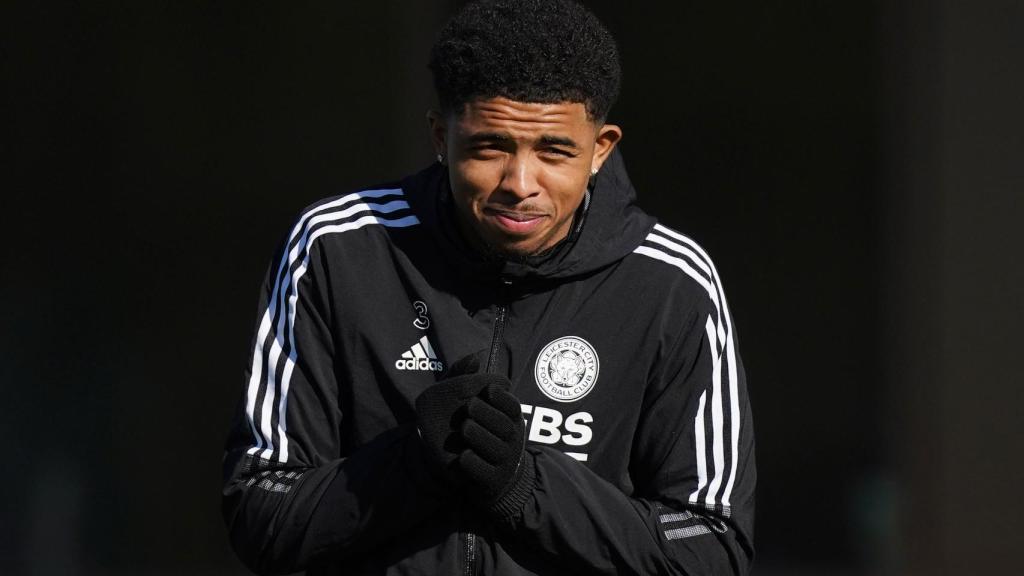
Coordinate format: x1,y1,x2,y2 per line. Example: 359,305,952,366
402,149,655,283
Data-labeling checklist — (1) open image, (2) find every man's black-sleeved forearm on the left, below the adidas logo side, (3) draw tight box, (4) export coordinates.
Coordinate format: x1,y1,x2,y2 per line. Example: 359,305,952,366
224,425,439,574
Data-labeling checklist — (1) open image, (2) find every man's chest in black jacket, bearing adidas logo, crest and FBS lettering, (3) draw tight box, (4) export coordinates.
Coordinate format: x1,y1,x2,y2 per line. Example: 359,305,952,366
335,264,658,476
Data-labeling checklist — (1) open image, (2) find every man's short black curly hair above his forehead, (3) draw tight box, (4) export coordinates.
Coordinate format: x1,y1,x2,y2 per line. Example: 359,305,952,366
429,0,622,121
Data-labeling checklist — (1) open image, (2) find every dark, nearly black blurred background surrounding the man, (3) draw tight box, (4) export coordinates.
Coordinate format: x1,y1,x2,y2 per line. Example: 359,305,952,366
0,0,1024,576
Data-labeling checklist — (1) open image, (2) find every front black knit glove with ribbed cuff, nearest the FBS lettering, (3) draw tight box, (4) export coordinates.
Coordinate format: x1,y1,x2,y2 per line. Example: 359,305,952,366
457,383,535,517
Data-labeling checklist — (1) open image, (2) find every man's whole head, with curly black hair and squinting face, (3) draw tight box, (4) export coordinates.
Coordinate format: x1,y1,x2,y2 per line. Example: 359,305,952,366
430,0,622,257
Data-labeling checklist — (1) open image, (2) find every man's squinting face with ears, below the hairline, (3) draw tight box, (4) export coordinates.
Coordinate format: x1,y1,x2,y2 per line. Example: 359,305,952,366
430,97,622,257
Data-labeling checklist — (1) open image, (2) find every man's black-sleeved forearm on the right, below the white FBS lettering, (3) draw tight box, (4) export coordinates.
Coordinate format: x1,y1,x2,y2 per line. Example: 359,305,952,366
504,448,753,575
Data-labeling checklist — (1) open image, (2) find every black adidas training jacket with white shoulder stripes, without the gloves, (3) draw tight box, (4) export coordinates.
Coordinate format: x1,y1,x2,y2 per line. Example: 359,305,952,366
223,152,755,576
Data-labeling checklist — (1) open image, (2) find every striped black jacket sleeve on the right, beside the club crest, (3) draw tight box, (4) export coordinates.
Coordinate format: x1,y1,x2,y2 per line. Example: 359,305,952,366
505,297,756,575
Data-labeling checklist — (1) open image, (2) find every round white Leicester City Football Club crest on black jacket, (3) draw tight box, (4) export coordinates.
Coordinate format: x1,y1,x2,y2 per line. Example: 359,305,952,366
534,336,600,402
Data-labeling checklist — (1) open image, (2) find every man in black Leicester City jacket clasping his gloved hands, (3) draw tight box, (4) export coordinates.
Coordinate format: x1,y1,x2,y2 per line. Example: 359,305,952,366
224,0,755,574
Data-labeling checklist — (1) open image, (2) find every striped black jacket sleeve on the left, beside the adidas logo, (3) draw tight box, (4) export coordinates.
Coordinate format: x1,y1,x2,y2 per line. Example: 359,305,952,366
222,235,437,574
